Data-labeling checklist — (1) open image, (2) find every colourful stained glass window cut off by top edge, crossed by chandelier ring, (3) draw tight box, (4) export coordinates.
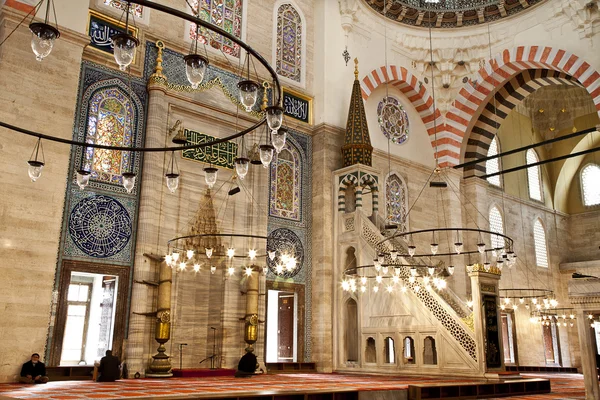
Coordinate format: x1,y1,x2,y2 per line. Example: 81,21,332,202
190,0,242,57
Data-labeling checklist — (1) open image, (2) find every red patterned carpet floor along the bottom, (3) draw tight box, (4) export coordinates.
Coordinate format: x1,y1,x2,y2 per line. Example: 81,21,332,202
0,374,585,400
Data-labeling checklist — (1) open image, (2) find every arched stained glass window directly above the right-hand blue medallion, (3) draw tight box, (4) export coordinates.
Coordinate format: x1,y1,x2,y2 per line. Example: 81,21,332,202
269,142,302,221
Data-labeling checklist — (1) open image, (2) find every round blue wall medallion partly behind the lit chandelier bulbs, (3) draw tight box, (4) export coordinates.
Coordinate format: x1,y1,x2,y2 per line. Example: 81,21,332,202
267,228,304,278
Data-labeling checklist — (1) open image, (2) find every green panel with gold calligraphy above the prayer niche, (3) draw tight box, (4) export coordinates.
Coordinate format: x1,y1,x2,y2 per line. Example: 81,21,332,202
183,129,238,169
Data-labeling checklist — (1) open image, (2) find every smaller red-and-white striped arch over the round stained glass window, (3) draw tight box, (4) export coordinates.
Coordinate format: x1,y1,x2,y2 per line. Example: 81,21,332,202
360,65,446,164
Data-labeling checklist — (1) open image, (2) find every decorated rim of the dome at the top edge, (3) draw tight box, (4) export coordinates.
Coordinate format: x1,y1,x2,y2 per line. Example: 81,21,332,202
365,0,545,28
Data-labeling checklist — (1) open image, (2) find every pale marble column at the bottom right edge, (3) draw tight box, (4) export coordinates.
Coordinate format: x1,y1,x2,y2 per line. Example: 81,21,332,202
577,308,600,400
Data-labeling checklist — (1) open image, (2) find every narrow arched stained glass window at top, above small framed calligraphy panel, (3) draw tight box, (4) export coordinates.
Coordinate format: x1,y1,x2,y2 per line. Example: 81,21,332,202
275,4,303,82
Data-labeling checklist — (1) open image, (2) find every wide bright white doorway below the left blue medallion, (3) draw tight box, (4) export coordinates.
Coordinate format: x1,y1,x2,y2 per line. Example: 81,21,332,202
59,271,118,366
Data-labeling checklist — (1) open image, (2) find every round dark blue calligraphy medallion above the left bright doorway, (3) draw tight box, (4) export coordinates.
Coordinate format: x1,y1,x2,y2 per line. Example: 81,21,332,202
68,195,132,258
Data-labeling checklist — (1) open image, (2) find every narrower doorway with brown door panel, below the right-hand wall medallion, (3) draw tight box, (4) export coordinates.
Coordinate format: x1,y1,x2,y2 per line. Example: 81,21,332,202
267,290,298,362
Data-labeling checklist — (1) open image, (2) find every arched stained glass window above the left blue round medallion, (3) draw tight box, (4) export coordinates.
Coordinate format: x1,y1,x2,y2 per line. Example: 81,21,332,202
84,88,134,184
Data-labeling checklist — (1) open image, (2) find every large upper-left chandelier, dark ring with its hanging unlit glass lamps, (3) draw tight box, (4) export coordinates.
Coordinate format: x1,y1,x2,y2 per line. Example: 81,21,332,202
0,0,287,192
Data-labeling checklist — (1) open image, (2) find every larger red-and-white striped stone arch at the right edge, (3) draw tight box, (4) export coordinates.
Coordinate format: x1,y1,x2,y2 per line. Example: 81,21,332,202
450,46,600,166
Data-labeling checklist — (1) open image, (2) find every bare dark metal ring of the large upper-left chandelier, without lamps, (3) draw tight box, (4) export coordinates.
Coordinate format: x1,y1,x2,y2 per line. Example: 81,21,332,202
0,0,281,153
